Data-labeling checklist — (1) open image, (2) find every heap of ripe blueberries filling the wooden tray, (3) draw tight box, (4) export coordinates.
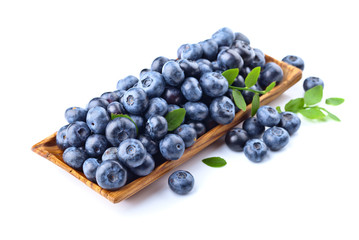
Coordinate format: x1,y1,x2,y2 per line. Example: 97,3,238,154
56,28,292,193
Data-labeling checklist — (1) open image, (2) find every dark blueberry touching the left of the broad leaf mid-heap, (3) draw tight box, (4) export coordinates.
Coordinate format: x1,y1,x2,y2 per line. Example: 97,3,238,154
145,115,168,141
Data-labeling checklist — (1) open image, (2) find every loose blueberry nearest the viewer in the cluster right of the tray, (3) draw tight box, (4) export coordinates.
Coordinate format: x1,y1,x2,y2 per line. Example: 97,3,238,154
243,138,268,163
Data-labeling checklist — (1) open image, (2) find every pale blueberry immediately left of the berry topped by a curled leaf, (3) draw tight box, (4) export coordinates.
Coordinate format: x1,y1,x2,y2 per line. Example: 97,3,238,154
86,106,111,134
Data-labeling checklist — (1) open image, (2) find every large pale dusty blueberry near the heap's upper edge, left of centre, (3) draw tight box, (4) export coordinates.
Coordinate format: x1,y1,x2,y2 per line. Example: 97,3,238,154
141,71,166,98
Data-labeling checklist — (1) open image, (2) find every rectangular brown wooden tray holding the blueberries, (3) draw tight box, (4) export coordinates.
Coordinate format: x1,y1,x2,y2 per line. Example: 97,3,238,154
32,55,302,203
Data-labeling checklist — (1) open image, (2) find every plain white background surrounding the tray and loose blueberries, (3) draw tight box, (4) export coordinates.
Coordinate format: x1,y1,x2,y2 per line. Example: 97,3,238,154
0,0,359,240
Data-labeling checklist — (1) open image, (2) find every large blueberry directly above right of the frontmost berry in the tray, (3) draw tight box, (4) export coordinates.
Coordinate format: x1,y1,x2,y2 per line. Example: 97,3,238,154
117,138,147,167
